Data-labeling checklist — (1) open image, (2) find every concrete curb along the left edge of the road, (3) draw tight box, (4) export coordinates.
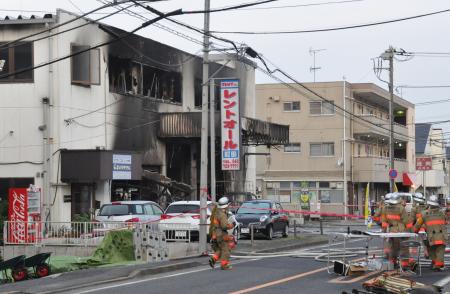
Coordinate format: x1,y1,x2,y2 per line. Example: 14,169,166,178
37,261,202,294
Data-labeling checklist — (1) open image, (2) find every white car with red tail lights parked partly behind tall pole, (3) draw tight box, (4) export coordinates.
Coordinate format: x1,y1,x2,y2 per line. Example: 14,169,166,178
159,201,213,242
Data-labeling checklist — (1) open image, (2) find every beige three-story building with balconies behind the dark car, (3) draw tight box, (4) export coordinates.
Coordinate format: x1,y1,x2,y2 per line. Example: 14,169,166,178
256,81,415,213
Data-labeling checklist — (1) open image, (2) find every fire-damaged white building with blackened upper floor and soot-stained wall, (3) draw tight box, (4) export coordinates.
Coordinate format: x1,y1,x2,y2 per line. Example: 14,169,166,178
0,10,288,221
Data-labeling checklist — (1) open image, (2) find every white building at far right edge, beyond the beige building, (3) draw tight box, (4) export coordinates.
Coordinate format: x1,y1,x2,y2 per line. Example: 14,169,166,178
416,123,447,198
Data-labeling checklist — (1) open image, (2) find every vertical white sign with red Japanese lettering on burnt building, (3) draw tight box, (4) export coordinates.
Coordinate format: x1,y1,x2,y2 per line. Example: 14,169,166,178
220,80,241,170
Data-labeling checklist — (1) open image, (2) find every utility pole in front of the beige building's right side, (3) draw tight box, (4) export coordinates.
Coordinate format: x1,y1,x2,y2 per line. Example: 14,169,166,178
381,46,395,193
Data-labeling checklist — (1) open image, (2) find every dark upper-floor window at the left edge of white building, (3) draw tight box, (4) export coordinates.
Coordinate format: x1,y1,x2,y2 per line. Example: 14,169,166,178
0,42,34,83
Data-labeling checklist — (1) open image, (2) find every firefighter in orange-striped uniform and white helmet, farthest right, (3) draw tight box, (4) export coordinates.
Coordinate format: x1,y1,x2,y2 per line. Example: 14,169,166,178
415,195,448,271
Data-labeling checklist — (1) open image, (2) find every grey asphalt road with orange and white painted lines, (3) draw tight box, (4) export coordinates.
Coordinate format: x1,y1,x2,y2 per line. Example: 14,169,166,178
60,242,450,294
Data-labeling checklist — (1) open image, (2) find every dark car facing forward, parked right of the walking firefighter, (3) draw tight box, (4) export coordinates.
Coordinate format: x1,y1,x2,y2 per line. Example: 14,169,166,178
235,200,289,240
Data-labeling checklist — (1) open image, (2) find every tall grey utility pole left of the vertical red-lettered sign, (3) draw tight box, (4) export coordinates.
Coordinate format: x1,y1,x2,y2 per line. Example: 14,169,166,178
199,0,209,254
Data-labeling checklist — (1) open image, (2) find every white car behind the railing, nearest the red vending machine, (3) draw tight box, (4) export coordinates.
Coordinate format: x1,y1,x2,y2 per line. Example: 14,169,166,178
95,201,163,222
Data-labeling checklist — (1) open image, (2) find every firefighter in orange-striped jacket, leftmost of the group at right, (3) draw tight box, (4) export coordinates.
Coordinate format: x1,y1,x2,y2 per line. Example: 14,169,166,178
381,193,413,267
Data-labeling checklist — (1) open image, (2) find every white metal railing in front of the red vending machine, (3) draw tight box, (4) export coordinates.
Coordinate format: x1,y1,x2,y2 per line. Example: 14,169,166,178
3,221,135,246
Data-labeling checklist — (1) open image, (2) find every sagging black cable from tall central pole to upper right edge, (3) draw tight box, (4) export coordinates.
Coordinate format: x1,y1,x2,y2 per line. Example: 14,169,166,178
211,9,450,35
